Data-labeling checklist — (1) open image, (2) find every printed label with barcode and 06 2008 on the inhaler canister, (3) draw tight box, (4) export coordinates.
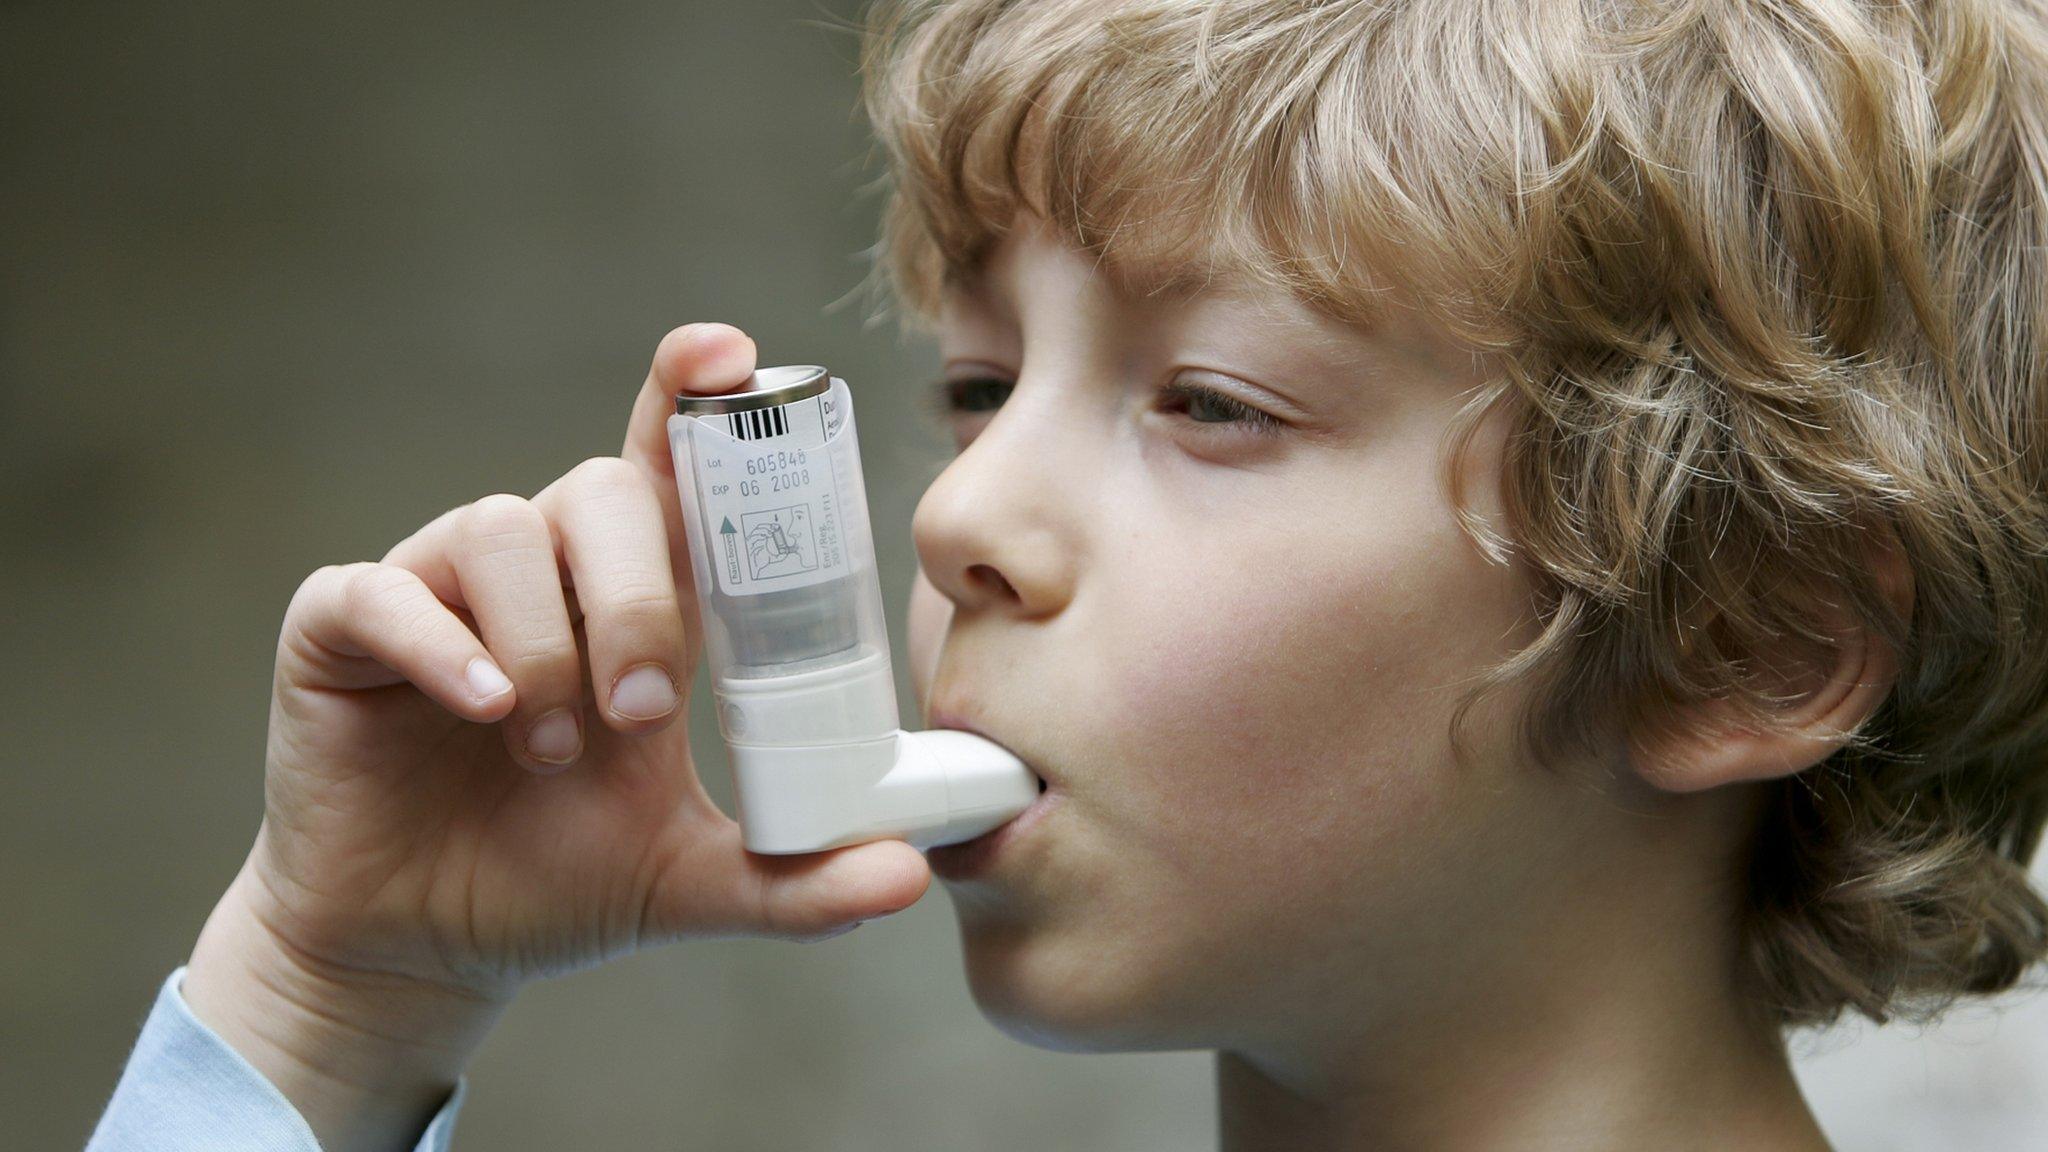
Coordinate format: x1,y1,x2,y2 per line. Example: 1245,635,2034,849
690,392,846,596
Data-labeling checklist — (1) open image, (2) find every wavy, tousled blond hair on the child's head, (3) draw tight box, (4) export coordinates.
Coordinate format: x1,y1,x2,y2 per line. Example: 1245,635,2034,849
862,0,2048,1023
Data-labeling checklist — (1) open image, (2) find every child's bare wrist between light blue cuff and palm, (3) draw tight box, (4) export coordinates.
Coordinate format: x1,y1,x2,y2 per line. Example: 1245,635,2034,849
182,867,508,1152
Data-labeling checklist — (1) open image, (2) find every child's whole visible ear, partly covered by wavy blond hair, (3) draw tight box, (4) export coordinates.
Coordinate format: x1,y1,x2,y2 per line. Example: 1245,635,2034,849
1630,541,1913,791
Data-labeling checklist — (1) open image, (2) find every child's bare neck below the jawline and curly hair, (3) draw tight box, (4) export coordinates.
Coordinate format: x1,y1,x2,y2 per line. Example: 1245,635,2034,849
1217,807,1829,1152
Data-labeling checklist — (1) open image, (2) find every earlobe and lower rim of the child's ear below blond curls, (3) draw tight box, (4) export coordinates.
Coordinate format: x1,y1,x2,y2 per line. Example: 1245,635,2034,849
1630,625,1898,791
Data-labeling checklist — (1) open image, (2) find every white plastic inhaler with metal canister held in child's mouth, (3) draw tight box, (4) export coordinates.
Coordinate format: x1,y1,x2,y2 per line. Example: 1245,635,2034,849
668,365,1038,853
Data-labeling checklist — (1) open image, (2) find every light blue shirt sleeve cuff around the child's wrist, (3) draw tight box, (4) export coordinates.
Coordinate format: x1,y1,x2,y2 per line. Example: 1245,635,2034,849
86,968,469,1152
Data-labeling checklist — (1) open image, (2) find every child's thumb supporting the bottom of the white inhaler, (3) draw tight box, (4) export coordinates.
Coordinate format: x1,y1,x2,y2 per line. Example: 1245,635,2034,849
647,822,932,941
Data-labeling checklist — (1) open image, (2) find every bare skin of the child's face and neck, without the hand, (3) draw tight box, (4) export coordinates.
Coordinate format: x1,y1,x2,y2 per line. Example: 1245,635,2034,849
909,219,1882,1148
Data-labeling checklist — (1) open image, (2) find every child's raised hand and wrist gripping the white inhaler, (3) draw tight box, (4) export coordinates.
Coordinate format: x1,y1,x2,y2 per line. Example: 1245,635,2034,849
184,324,930,1152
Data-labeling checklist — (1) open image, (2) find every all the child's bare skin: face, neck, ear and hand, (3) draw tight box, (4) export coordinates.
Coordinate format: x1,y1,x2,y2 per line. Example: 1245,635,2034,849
184,217,1888,1152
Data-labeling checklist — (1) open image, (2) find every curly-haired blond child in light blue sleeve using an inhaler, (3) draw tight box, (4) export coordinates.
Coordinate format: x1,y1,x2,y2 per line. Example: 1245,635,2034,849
83,0,2048,1152
